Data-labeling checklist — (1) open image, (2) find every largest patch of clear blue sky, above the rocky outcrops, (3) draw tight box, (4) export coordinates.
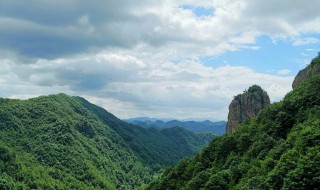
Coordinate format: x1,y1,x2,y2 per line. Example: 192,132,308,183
200,34,320,76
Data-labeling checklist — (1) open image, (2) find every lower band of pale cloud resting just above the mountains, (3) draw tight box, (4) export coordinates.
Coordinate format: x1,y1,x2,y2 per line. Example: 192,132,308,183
0,52,293,119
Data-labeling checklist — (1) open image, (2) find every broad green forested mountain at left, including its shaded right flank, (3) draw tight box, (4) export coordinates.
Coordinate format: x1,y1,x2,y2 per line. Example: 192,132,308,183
0,94,206,189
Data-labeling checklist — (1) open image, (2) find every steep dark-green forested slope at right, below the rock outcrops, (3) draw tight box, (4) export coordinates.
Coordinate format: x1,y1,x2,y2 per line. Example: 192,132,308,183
147,59,320,190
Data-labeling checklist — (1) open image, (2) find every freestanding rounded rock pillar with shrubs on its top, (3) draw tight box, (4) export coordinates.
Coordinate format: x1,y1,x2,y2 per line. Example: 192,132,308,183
227,85,270,133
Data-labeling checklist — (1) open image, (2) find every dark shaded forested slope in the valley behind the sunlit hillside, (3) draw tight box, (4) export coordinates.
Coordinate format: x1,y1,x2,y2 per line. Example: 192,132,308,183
74,97,207,168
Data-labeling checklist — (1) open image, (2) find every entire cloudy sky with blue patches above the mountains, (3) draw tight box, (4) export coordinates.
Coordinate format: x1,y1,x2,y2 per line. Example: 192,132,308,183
0,0,320,120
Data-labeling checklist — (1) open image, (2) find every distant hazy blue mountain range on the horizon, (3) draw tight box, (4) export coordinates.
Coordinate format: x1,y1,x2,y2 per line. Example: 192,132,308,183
126,118,226,135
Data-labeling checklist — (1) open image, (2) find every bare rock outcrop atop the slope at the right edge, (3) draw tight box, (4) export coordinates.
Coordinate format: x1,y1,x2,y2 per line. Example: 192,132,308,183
292,55,320,89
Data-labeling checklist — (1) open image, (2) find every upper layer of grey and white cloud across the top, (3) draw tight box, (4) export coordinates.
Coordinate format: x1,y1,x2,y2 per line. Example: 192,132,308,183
0,0,320,59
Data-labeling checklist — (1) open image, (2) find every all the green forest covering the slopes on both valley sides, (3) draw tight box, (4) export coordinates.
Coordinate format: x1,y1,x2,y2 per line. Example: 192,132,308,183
0,58,320,190
